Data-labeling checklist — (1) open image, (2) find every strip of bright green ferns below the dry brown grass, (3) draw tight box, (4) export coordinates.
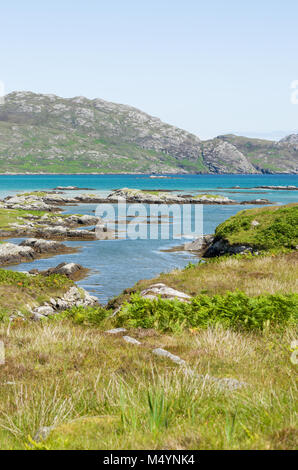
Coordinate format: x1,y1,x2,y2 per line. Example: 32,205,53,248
115,292,298,333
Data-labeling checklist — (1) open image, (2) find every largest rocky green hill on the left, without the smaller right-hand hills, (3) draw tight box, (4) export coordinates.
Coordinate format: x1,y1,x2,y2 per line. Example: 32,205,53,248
0,92,207,173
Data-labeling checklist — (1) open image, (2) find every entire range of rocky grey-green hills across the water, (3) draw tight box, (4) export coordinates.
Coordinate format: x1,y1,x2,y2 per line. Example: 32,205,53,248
0,92,298,174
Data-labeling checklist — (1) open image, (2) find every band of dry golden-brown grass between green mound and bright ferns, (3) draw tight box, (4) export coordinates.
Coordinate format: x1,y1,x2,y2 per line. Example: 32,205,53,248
111,252,298,305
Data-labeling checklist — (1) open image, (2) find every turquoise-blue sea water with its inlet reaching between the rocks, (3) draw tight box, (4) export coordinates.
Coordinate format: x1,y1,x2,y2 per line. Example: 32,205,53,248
0,175,298,303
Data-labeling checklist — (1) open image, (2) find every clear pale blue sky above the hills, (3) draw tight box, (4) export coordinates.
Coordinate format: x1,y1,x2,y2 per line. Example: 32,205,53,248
0,0,298,138
